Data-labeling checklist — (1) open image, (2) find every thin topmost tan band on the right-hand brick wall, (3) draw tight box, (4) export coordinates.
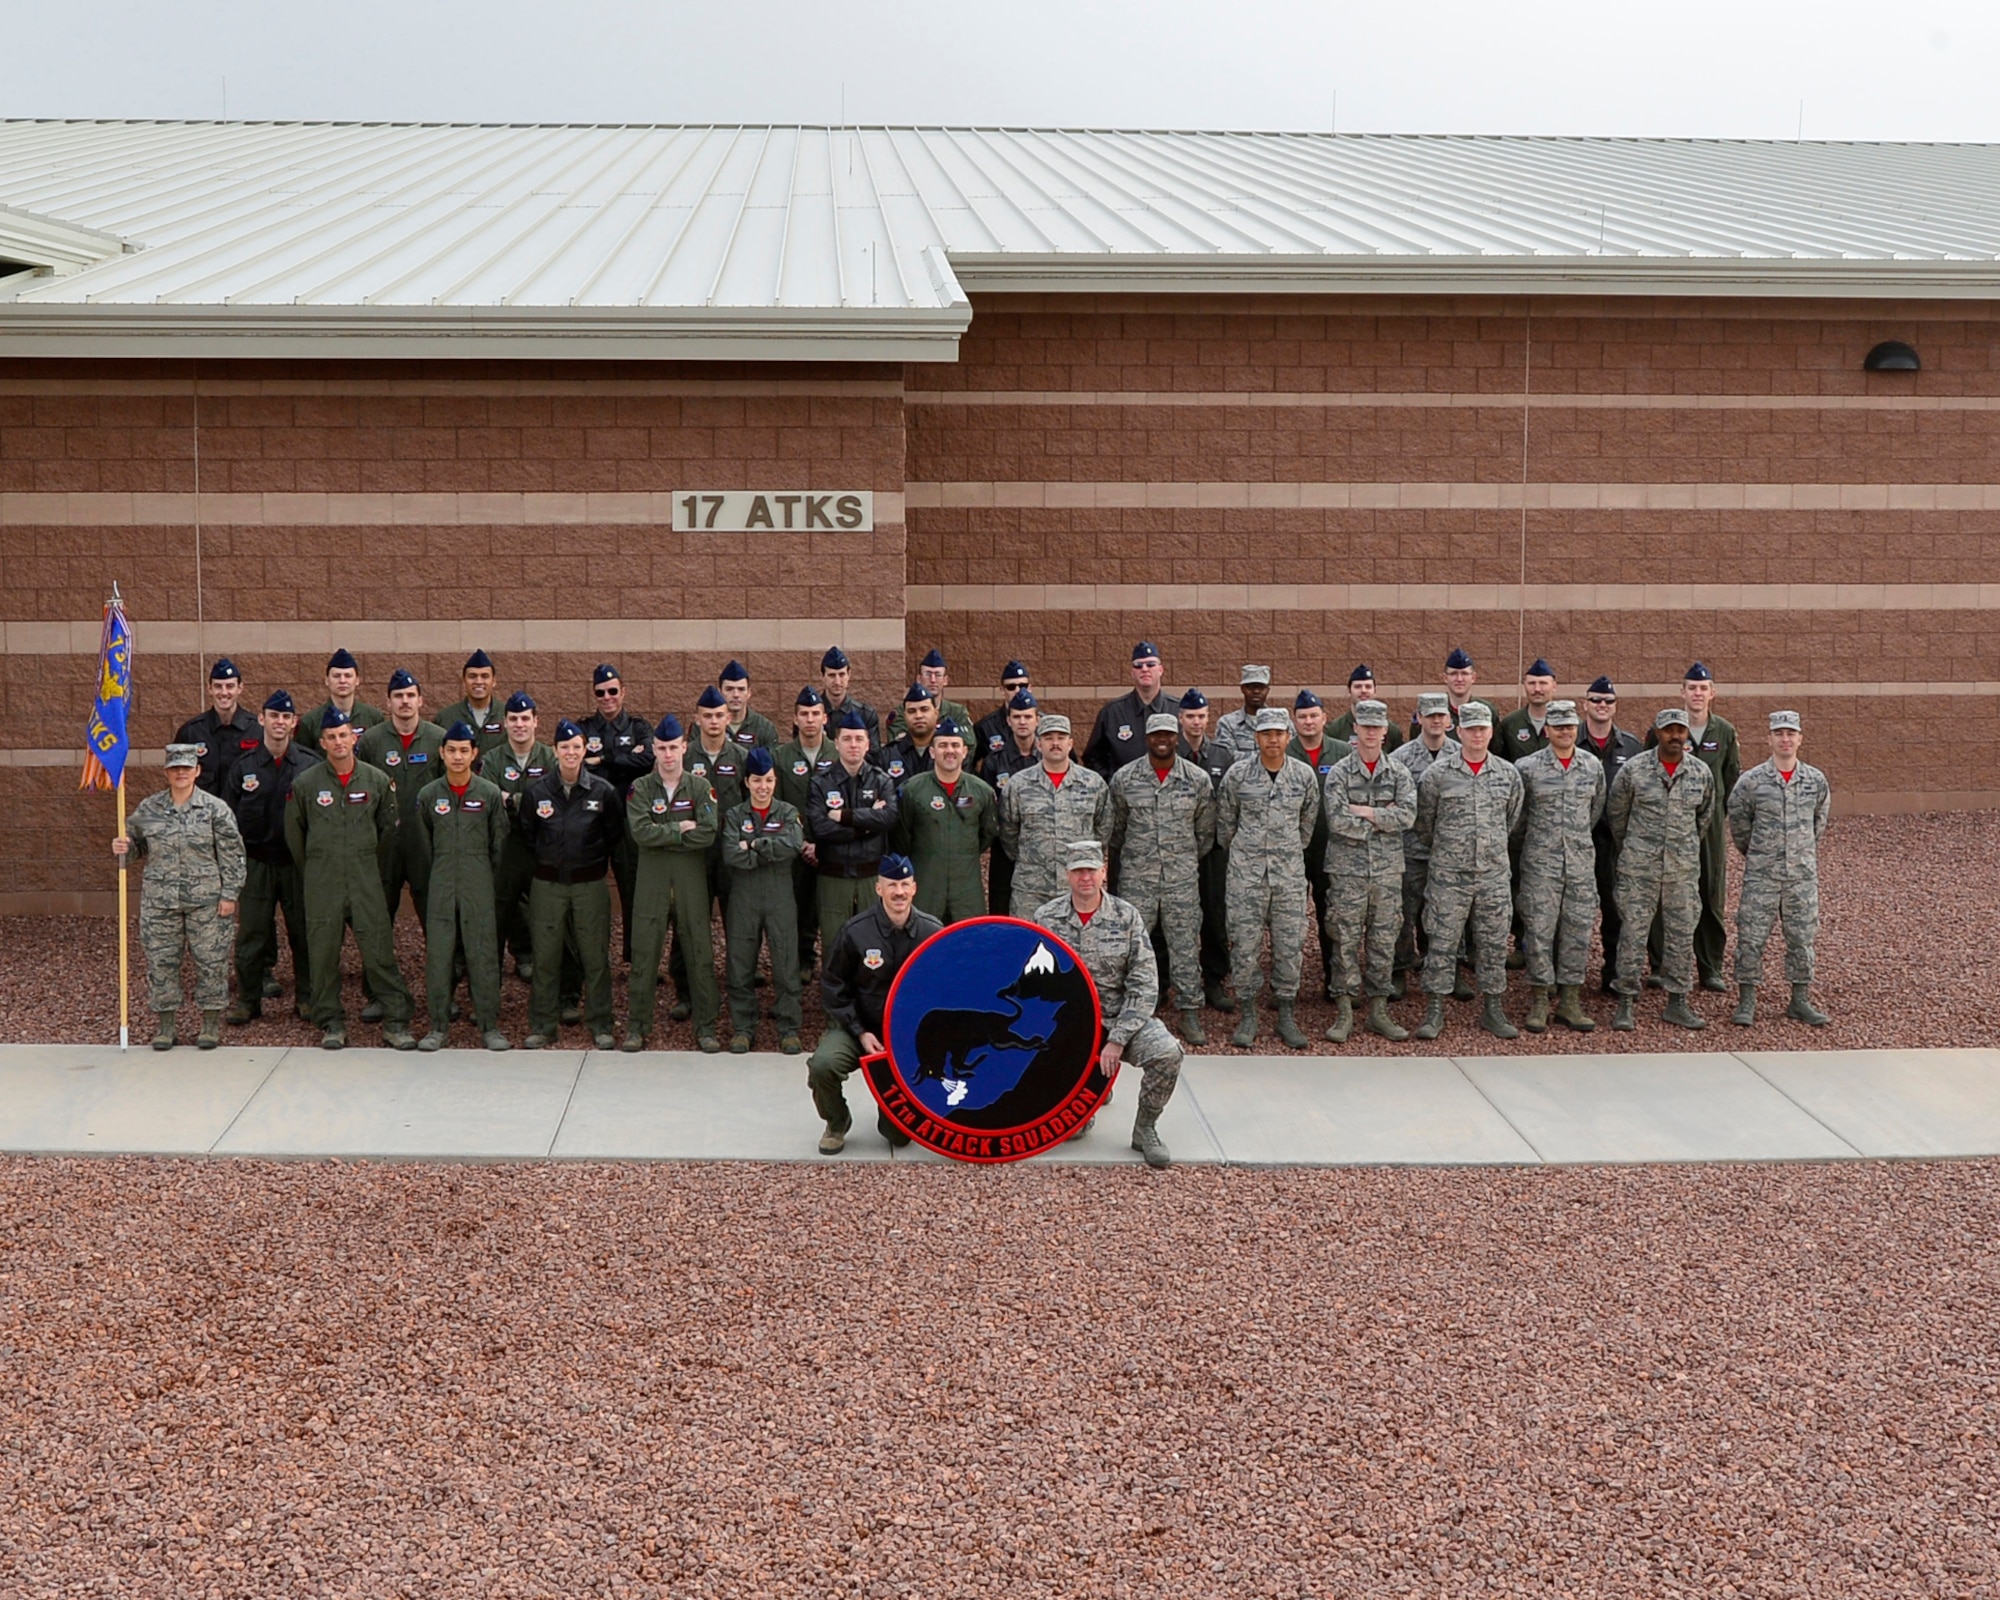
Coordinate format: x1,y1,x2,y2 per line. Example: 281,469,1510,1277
912,388,2000,412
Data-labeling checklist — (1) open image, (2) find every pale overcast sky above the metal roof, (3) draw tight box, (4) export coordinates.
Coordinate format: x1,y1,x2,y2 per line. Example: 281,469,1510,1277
11,0,2000,140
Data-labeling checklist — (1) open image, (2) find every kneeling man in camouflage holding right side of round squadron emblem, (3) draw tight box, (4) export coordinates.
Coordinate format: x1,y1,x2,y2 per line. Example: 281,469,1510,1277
1034,844,1176,1166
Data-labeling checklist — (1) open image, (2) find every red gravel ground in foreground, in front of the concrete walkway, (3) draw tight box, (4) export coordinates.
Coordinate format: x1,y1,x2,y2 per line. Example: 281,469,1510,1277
0,1160,2000,1600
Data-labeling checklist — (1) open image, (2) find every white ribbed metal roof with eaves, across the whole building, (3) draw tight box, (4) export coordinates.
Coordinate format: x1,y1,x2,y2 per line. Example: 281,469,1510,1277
0,122,2000,360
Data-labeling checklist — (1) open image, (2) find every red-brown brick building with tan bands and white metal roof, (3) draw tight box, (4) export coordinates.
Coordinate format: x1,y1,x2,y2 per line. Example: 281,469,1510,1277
0,122,2000,912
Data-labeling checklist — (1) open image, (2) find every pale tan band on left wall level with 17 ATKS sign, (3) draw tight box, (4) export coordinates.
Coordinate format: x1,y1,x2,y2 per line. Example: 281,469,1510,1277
0,488,904,538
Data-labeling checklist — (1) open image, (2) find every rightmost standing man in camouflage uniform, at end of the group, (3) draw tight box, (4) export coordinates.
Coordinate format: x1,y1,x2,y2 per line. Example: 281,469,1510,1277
1730,712,1834,1028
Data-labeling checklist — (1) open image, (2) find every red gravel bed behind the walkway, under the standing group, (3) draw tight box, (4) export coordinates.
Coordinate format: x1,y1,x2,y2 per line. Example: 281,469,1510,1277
0,812,2000,1056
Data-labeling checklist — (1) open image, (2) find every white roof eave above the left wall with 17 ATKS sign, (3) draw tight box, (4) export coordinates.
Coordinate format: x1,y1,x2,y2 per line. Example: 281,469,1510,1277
0,300,972,362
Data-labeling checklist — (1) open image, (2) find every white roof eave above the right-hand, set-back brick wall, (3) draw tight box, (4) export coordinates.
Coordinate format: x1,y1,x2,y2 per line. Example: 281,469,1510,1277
950,252,2000,300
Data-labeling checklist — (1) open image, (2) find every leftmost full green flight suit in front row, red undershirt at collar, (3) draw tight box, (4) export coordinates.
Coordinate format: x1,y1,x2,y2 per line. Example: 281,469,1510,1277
284,762,410,1030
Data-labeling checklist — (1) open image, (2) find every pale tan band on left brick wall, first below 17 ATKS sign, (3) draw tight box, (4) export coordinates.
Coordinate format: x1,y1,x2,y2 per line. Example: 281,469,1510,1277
0,616,904,656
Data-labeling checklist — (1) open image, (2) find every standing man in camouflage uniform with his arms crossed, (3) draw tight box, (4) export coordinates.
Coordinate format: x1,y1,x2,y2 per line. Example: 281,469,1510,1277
1322,700,1416,1044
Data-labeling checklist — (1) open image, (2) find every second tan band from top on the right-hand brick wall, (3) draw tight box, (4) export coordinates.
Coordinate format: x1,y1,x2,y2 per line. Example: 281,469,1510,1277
908,480,2000,510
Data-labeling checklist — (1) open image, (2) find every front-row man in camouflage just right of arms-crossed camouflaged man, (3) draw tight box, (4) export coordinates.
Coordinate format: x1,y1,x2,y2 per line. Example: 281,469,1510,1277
1416,700,1520,1038
